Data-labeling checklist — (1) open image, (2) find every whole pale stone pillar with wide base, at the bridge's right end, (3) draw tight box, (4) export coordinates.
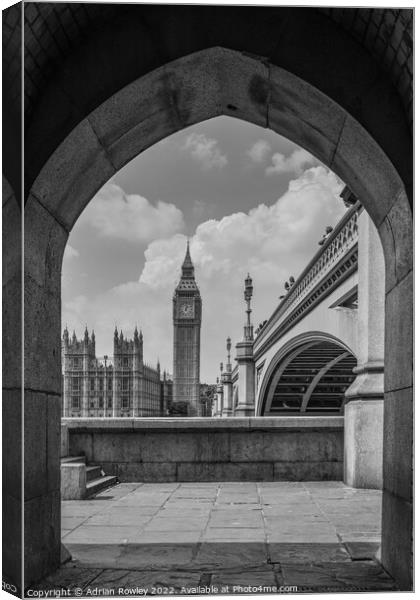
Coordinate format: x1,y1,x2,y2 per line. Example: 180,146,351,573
344,211,385,489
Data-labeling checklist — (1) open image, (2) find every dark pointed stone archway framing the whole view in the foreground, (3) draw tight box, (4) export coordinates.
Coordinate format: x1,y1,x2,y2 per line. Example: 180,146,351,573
21,47,412,589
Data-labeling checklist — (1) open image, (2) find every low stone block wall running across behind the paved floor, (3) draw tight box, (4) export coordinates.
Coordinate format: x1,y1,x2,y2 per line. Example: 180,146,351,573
63,417,343,482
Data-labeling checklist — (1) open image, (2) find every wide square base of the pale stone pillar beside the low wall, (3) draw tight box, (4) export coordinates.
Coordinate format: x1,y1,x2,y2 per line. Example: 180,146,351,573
344,398,384,490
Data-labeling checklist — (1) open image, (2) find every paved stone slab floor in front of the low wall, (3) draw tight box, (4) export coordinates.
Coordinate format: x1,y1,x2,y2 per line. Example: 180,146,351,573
35,482,396,596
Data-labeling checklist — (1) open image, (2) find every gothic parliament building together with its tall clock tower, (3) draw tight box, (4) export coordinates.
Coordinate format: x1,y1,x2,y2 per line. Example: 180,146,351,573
62,244,201,418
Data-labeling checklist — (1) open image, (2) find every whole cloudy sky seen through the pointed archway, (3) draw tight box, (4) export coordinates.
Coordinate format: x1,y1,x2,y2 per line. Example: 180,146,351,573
62,117,345,383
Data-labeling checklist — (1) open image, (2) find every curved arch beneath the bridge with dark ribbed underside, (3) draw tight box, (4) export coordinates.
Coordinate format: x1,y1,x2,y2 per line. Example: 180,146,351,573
257,331,357,416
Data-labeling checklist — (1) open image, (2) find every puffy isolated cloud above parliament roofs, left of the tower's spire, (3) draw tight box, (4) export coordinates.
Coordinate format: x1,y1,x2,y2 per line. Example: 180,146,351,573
81,183,185,242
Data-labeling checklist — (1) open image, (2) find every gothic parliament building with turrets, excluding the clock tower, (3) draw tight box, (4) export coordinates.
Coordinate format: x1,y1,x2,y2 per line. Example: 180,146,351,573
62,327,172,417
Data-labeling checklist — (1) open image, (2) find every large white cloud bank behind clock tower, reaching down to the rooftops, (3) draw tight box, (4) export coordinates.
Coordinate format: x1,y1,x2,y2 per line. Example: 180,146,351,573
63,166,345,382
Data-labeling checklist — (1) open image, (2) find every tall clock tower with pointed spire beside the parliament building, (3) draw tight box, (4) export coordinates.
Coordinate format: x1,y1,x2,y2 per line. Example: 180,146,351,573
172,242,201,417
